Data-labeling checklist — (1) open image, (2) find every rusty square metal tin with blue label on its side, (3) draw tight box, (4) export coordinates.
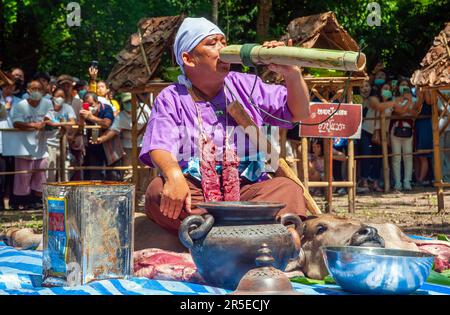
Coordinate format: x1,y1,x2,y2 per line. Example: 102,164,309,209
42,181,135,286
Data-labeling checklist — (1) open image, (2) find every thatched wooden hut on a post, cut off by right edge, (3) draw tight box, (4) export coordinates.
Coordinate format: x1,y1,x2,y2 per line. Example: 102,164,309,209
411,22,450,211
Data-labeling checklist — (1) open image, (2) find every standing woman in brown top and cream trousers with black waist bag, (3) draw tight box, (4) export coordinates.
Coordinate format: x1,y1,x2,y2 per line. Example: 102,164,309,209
389,80,414,191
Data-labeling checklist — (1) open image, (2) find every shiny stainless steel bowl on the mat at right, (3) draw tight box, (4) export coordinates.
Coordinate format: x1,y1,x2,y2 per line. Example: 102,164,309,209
322,246,434,294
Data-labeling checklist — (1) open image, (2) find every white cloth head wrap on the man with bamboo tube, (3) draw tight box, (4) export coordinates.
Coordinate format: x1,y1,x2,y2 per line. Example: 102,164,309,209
173,18,225,88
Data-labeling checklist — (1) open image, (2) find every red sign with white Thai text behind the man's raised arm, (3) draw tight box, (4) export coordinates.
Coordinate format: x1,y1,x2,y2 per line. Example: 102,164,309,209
299,103,362,139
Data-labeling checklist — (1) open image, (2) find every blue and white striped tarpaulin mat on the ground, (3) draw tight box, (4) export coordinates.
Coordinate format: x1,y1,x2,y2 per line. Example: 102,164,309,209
0,242,450,295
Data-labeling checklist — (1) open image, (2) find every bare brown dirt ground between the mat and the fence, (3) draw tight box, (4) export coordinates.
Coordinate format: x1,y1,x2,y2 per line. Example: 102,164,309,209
0,188,450,236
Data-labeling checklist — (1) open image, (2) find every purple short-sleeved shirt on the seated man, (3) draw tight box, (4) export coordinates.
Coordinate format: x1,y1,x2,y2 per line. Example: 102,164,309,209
139,72,292,168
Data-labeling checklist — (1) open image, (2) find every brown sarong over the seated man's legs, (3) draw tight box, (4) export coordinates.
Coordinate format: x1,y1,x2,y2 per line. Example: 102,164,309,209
145,177,306,233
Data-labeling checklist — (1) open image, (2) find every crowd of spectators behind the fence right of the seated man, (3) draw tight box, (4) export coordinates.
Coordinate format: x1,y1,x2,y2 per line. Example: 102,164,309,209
288,63,450,194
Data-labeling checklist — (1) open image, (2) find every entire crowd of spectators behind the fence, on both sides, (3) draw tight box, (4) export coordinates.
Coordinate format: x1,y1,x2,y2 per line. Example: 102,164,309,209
0,63,450,210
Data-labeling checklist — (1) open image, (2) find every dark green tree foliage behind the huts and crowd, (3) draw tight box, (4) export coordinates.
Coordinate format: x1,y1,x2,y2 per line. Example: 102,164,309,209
0,0,450,78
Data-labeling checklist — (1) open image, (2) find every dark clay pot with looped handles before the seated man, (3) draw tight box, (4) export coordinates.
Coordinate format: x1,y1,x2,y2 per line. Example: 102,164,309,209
179,202,302,290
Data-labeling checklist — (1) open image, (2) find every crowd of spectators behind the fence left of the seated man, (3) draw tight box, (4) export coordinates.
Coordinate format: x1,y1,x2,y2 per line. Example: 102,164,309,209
0,67,150,210
